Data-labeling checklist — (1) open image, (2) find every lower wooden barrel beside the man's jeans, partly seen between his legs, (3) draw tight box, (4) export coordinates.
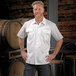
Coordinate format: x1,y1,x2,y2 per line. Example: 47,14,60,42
9,59,38,76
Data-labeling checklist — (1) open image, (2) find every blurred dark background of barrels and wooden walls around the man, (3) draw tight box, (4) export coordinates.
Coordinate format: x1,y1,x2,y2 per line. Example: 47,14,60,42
0,0,76,76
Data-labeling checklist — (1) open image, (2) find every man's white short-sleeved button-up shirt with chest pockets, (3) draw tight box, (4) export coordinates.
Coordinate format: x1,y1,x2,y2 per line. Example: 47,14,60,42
17,18,63,65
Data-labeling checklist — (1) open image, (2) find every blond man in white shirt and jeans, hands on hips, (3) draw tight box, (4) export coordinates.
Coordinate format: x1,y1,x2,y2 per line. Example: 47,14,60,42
17,1,63,76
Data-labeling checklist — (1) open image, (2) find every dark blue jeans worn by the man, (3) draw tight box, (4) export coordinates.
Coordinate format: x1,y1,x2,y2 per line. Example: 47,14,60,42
24,63,50,76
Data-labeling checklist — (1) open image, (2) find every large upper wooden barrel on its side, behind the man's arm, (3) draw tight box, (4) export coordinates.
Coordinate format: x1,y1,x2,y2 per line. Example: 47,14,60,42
0,20,22,49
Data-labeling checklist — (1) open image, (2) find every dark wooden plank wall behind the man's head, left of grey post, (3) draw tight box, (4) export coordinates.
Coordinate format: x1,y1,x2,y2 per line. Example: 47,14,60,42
9,0,47,19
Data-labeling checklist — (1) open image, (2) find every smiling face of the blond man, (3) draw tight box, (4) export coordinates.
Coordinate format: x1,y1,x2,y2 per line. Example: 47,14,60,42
33,4,44,18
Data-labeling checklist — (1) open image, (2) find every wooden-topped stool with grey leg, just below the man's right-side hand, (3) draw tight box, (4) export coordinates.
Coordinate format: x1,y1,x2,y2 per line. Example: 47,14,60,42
50,60,64,76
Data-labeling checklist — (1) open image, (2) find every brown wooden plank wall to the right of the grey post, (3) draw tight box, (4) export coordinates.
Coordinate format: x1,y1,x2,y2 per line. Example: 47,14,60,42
58,0,76,42
